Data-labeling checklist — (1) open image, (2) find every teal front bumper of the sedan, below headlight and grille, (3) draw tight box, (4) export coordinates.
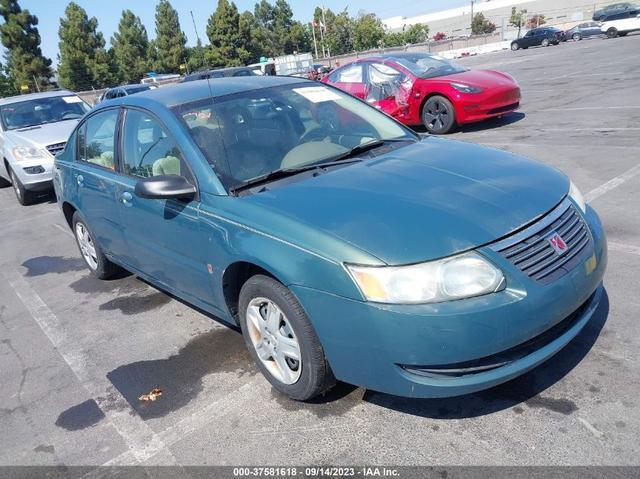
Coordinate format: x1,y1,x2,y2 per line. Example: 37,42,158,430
291,202,607,397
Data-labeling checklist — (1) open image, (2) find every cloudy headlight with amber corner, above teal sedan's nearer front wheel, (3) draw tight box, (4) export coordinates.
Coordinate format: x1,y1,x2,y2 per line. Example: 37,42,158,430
346,252,504,304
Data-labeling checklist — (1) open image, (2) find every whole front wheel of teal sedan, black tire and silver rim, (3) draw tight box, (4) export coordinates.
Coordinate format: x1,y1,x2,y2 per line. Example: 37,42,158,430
239,275,335,401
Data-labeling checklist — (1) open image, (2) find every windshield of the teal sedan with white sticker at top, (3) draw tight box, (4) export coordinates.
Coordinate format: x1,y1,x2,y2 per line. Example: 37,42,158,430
174,83,416,188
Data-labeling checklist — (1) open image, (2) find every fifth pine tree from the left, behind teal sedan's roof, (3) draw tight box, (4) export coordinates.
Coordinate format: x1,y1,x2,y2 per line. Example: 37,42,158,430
207,0,242,66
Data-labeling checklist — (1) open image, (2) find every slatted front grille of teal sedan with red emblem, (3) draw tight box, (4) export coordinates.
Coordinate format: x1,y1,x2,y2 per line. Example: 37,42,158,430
492,200,593,284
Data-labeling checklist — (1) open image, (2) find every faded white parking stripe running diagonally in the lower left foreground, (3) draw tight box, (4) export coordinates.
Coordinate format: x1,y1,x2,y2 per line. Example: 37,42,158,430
3,270,177,464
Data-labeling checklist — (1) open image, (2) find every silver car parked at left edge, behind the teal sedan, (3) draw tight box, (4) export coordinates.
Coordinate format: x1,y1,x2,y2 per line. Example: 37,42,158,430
0,90,89,205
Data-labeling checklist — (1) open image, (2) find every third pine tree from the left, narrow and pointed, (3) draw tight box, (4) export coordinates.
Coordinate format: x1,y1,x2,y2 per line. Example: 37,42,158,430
111,10,149,83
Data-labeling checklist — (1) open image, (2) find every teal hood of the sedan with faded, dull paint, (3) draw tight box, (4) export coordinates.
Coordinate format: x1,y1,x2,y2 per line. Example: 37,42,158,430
244,138,569,264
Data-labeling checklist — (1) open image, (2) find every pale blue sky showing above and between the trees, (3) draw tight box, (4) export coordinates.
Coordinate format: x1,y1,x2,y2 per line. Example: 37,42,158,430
20,0,469,65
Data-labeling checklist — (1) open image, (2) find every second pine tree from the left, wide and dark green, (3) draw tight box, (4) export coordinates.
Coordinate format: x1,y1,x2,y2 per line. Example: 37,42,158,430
58,2,116,91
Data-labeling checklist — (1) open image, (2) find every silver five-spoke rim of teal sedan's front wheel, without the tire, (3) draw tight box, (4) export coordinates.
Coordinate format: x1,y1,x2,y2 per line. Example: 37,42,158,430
246,298,302,384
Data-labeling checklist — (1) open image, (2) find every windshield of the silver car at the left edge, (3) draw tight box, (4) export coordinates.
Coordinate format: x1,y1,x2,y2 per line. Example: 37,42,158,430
0,95,89,130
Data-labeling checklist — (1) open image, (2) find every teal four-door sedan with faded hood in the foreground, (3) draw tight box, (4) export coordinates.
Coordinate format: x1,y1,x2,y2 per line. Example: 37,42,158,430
54,77,607,400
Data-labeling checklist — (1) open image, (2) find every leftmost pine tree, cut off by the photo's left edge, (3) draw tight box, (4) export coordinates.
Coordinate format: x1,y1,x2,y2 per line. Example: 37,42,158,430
0,0,52,91
